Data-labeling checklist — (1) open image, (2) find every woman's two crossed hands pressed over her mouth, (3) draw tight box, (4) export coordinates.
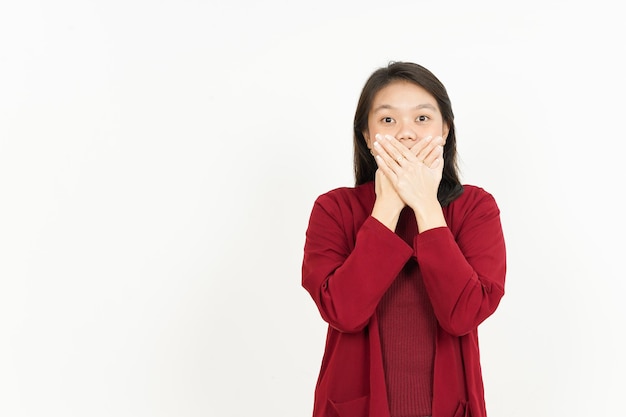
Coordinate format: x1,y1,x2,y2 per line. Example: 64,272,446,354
374,135,444,212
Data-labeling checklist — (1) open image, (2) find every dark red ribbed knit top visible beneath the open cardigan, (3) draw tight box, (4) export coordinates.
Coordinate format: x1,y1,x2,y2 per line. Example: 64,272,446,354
378,208,437,417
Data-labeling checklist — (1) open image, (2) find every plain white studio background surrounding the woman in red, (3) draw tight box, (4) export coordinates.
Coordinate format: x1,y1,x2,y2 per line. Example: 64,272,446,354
0,0,626,417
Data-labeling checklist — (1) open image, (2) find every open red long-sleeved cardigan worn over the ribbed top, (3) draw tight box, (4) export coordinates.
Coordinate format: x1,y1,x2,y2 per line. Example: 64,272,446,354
302,182,506,417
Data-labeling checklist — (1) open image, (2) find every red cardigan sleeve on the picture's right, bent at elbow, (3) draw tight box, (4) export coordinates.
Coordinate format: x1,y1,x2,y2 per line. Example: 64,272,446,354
414,194,506,336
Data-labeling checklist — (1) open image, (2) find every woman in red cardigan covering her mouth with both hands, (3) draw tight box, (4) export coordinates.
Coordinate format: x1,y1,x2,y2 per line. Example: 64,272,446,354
302,62,506,417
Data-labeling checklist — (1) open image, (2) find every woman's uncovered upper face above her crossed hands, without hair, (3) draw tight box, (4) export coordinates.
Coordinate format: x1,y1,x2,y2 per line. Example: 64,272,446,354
363,80,449,149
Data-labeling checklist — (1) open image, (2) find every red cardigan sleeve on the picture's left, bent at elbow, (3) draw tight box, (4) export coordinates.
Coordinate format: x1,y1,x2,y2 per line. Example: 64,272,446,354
302,196,413,332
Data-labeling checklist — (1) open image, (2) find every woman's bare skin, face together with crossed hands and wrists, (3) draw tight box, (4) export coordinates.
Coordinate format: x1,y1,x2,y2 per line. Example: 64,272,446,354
363,81,449,233
